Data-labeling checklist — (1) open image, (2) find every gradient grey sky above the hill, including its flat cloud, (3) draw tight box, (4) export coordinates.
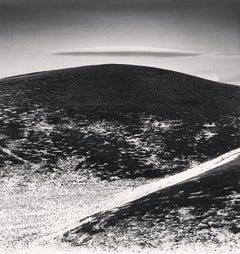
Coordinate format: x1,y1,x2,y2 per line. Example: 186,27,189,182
0,0,240,84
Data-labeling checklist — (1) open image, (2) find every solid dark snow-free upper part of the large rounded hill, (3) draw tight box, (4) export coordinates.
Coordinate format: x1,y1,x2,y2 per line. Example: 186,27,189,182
1,65,240,117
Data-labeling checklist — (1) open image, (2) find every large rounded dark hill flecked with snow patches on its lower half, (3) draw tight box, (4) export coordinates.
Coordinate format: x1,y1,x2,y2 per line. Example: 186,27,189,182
0,65,240,179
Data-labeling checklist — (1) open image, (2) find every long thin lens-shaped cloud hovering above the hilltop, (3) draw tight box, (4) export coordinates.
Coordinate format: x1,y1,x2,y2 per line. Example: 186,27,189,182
52,48,203,57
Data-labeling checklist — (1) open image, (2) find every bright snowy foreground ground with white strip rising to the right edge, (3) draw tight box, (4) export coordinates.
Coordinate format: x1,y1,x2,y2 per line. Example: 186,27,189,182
0,149,240,254
